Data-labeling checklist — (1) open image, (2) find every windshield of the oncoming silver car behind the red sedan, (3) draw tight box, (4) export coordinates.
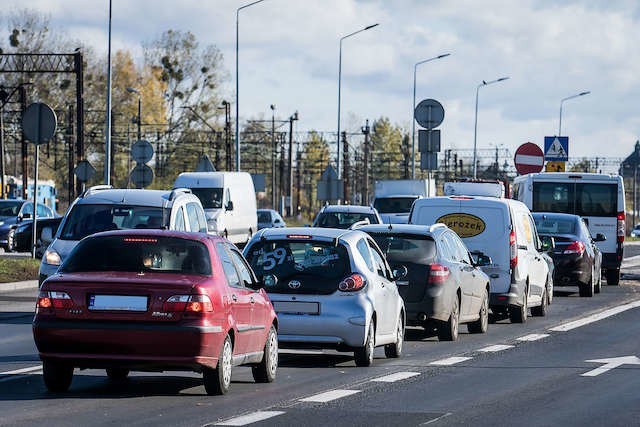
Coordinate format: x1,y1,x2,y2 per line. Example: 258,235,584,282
60,205,169,240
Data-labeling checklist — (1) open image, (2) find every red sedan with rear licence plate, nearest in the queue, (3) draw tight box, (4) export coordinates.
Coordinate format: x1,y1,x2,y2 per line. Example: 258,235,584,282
33,230,278,394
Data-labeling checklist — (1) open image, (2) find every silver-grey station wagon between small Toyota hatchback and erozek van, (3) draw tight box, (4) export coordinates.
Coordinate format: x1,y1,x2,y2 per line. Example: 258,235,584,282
358,224,491,341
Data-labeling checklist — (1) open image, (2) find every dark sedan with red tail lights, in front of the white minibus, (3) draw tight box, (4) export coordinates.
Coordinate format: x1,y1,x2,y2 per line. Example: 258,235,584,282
533,212,606,297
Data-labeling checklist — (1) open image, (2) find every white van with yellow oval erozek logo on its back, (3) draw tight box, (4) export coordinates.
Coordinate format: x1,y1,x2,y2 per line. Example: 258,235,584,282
409,196,553,323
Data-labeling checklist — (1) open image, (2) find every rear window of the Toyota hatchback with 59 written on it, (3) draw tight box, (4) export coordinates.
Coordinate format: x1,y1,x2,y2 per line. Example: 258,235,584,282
245,240,350,294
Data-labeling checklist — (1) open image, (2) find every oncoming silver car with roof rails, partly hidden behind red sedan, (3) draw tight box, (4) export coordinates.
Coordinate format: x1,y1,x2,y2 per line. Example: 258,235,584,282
39,185,207,283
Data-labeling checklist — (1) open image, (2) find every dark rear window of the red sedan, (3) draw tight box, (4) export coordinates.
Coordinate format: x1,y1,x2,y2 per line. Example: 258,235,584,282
59,236,211,276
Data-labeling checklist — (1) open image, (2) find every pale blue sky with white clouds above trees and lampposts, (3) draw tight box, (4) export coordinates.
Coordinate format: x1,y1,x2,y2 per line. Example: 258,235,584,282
3,0,640,169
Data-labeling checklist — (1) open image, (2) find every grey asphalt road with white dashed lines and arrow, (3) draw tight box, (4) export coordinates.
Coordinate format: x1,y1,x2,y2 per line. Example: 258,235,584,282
0,245,640,426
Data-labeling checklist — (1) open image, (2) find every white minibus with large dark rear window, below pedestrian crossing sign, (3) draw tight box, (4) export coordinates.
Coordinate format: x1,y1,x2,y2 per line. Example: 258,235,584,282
513,172,625,286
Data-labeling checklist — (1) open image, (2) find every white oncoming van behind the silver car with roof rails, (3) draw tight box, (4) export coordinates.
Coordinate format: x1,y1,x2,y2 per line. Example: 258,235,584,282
173,172,258,244
